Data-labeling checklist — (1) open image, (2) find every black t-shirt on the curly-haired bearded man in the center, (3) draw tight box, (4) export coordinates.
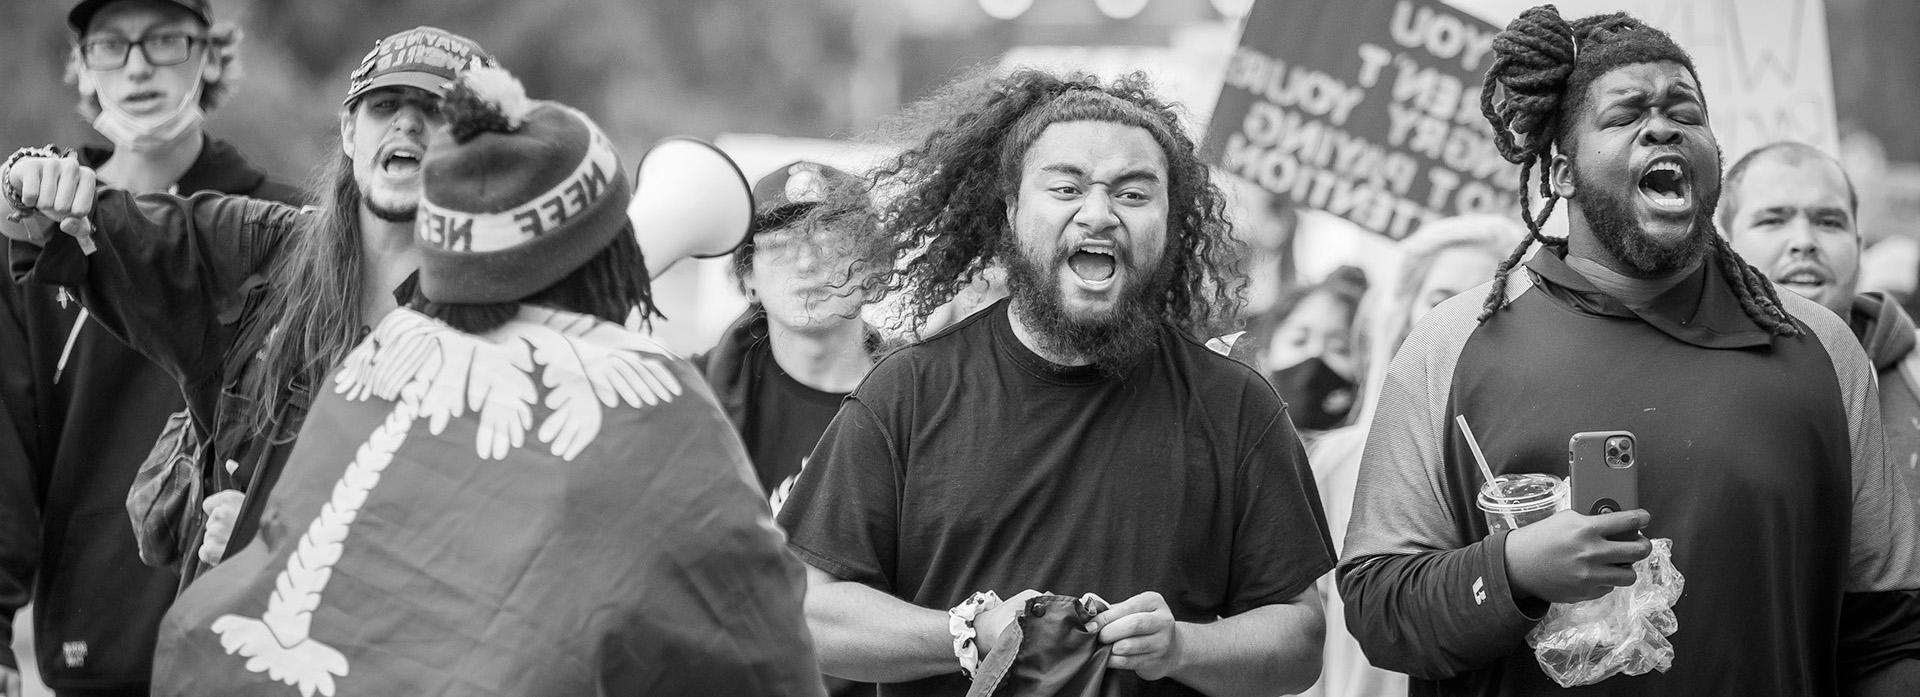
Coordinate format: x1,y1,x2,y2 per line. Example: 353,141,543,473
780,301,1332,695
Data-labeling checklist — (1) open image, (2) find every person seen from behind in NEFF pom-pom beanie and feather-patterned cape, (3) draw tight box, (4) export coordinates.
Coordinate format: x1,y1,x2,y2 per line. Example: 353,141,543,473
139,67,822,697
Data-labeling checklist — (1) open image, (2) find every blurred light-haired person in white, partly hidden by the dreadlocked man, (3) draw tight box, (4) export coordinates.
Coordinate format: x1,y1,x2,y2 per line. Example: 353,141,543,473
1304,215,1526,697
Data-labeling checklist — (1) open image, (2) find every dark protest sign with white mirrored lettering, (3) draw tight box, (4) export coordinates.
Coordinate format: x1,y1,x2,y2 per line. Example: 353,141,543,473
1206,0,1519,238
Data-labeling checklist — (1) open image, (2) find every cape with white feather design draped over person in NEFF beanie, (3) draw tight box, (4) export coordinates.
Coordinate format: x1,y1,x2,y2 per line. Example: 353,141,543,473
154,307,820,697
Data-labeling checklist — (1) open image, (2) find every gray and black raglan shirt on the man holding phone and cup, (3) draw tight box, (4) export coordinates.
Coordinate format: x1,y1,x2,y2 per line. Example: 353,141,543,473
1340,252,1920,697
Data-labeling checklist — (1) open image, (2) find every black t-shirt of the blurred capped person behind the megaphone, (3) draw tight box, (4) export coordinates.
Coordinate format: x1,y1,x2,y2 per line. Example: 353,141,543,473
741,342,847,511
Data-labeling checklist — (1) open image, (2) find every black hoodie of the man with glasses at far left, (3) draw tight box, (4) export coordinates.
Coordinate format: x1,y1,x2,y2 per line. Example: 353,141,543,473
0,138,301,689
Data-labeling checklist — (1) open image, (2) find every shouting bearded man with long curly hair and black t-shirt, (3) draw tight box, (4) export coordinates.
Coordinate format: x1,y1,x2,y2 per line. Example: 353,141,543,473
780,71,1332,695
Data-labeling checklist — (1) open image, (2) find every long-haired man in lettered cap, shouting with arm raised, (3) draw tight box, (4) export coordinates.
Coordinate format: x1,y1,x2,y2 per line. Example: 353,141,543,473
0,27,493,584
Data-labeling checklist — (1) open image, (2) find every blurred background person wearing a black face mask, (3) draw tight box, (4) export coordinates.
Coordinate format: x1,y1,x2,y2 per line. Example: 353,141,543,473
1233,267,1367,439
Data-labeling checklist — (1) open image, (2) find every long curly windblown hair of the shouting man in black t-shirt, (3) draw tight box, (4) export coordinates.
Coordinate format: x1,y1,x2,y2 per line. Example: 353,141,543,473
864,69,1246,334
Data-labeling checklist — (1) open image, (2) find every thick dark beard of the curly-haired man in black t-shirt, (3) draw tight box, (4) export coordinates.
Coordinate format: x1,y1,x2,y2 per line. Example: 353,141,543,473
1000,240,1171,378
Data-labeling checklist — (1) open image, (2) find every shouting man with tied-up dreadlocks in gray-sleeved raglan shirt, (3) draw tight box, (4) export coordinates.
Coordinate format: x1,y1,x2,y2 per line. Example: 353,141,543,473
1340,6,1920,695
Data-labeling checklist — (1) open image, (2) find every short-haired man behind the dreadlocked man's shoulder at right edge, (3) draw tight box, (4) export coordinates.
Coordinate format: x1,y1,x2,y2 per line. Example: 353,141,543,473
1720,142,1920,503
